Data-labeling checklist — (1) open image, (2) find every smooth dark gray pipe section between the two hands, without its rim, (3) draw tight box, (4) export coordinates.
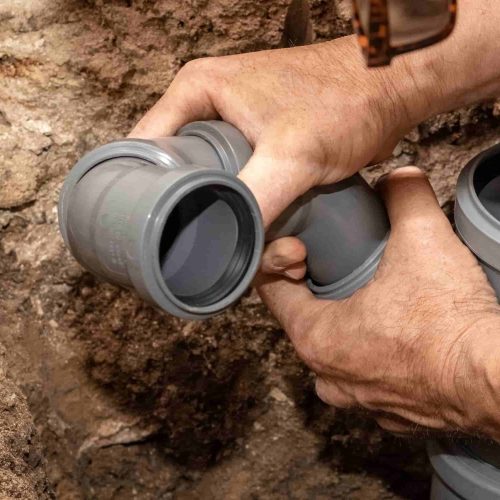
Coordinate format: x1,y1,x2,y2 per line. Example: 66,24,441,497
267,175,389,286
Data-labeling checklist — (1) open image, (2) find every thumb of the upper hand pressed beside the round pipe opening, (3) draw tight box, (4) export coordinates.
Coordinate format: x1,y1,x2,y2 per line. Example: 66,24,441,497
239,132,323,228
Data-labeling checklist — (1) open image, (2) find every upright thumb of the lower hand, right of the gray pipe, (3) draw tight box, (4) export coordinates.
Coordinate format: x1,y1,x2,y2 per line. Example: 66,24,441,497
377,167,451,231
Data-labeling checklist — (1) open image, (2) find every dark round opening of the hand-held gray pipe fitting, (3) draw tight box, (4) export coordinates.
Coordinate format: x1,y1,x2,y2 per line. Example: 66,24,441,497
159,185,256,307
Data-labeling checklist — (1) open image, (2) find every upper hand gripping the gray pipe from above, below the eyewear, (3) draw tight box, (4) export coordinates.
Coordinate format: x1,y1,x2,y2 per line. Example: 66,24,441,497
131,37,439,226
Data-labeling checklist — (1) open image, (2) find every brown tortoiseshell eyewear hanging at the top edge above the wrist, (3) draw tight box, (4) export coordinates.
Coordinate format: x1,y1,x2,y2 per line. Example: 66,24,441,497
353,0,457,66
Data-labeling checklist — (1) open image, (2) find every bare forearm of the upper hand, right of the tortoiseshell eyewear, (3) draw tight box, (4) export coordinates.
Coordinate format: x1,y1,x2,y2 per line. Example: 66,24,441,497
394,0,500,123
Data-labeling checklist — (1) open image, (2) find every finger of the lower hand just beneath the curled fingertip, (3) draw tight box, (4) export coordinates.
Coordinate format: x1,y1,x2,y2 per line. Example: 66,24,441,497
255,274,328,354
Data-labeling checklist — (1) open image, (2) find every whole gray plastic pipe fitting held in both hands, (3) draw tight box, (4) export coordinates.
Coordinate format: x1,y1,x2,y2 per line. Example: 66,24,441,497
59,121,389,319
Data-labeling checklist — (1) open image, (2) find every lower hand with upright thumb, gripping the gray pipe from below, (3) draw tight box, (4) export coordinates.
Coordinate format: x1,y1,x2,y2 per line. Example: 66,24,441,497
257,167,500,439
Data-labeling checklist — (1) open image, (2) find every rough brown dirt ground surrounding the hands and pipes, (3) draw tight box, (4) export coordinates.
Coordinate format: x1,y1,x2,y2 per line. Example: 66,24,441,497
0,0,500,500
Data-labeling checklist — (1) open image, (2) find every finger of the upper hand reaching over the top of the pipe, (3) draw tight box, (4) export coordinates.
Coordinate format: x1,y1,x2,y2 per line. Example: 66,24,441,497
129,61,219,139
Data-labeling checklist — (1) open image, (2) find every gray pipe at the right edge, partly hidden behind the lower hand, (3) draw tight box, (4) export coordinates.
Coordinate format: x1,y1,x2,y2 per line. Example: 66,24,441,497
428,145,500,500
